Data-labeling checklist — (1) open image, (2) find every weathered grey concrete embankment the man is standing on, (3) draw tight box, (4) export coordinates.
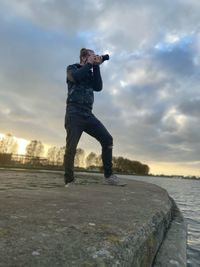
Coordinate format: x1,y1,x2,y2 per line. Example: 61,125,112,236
0,170,186,267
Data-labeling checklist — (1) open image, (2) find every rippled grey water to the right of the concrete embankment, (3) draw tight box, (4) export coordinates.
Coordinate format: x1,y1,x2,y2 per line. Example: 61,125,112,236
120,175,200,267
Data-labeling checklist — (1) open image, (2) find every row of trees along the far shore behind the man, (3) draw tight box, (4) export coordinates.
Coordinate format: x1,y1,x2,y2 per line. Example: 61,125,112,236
0,134,150,175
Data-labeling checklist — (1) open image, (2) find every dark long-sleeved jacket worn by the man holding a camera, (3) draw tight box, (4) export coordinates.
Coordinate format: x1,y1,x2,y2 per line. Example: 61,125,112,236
66,63,103,110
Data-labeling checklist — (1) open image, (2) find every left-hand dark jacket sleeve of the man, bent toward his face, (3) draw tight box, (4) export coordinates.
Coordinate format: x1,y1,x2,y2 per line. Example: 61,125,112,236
67,63,92,82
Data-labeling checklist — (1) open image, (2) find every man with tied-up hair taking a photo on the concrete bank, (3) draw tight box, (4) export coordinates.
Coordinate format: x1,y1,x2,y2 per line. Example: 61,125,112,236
64,48,119,187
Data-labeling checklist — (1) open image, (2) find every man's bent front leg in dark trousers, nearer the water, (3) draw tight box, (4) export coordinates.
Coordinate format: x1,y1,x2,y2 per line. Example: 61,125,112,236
84,114,113,178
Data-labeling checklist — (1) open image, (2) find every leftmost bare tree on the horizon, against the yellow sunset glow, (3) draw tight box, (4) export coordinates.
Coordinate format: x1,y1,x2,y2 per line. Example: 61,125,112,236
0,133,18,153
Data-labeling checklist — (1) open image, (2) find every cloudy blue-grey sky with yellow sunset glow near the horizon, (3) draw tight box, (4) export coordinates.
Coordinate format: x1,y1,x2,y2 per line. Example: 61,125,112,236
0,0,200,178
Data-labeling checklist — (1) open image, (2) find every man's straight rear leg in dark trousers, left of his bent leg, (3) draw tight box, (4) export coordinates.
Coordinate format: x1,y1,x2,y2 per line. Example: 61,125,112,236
64,115,83,184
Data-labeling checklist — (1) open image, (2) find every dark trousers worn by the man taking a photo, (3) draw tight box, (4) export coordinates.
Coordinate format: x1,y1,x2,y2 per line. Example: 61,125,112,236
64,107,113,183
